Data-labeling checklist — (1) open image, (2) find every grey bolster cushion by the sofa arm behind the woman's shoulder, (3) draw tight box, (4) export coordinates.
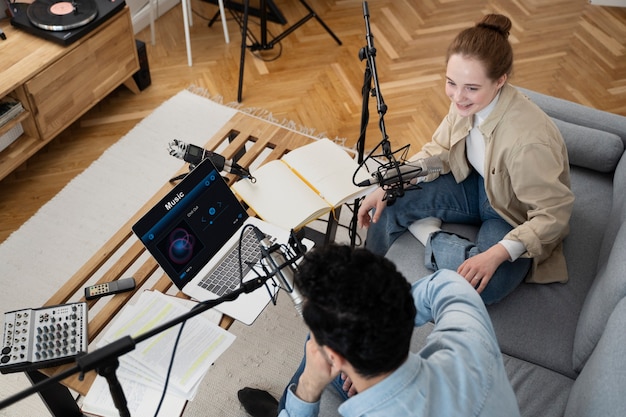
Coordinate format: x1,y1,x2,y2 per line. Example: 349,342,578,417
552,118,624,172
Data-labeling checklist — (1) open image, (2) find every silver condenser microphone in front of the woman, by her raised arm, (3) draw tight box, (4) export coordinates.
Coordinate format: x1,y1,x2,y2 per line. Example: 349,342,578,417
358,156,443,187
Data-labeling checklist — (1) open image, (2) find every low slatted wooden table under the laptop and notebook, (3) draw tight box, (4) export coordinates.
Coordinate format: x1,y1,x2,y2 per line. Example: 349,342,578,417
18,112,336,417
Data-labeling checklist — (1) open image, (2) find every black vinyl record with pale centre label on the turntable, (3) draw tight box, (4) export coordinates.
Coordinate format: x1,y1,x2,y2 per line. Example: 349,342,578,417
26,0,98,31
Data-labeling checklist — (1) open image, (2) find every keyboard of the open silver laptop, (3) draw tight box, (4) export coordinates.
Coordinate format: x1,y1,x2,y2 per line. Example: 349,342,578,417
198,227,261,296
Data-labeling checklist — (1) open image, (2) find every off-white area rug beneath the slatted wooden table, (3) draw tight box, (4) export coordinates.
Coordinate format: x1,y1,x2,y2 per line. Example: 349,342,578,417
0,91,313,417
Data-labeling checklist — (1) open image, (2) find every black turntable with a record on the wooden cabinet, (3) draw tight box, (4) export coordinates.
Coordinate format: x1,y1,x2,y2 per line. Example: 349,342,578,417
10,0,126,45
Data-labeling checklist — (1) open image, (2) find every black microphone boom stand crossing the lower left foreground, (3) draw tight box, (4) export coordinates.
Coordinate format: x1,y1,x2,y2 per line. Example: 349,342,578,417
0,274,274,417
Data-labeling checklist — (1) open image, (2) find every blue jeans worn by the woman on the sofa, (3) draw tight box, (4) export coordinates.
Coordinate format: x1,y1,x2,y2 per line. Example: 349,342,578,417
365,172,532,304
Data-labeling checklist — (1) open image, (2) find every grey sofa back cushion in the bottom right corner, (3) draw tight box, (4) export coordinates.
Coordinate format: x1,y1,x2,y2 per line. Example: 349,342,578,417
565,299,626,417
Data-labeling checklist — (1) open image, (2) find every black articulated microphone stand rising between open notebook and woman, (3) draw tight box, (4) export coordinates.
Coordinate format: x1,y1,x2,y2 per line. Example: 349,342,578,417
350,1,408,247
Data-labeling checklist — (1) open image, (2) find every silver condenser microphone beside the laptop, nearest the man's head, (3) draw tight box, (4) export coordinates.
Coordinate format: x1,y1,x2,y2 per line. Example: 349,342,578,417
254,227,303,316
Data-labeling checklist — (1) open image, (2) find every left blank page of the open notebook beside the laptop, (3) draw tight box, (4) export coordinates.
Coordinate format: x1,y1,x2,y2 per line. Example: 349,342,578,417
232,160,331,230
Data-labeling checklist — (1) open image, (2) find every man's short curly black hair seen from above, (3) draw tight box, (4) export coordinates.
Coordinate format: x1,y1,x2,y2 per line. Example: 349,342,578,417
295,244,416,377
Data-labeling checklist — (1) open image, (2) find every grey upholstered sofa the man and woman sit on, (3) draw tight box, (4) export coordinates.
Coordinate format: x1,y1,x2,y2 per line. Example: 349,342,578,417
387,89,626,417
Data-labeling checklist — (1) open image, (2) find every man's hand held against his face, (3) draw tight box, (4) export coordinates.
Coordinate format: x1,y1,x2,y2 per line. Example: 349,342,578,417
296,335,340,403
